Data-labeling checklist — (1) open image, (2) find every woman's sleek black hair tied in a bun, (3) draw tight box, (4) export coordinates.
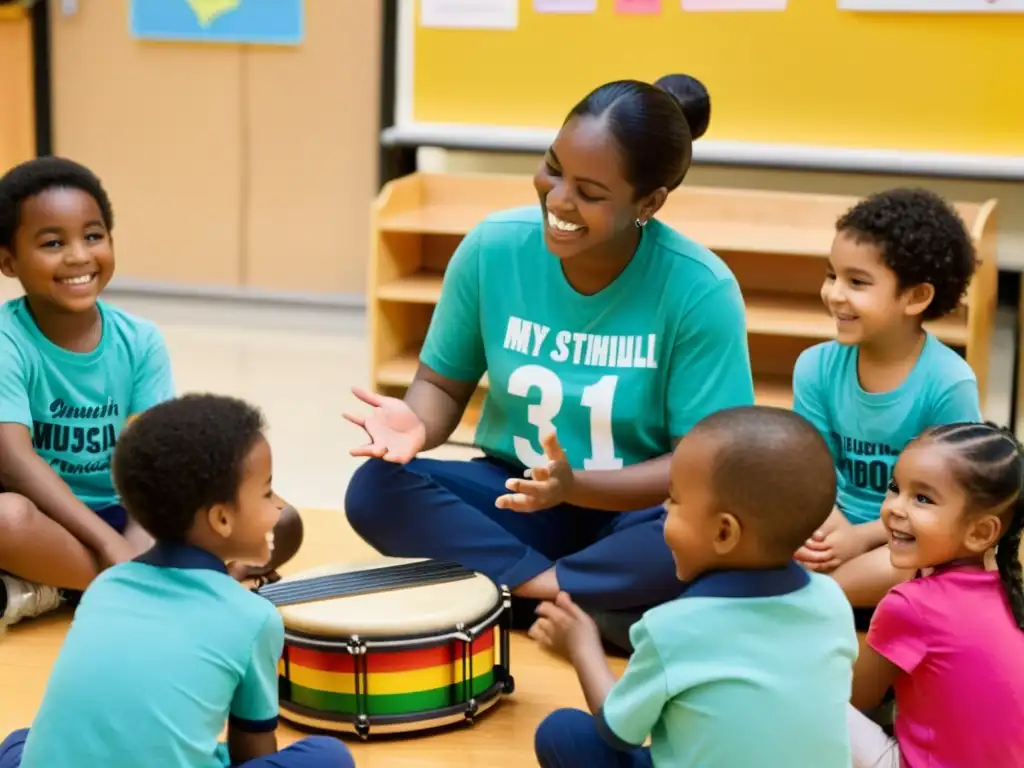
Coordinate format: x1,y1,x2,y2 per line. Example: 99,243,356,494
565,75,711,198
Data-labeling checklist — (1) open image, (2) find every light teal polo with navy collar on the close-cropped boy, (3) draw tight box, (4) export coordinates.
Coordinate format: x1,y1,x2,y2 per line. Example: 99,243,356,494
596,563,857,768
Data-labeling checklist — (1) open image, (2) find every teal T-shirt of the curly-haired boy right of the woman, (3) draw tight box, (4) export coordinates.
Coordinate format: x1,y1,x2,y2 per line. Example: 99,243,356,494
793,334,982,524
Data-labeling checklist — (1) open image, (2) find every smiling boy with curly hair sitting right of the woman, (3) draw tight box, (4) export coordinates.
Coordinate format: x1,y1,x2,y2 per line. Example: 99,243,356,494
793,188,982,630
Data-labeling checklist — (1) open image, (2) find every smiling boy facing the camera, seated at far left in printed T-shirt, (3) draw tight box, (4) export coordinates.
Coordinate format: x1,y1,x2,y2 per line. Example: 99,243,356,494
0,157,302,630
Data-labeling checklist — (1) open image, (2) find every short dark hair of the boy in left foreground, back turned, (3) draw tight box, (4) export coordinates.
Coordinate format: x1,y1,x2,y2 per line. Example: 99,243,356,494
113,394,265,543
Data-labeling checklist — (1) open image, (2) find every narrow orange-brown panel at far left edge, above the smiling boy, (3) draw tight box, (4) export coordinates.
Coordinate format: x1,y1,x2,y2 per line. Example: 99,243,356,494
0,8,36,174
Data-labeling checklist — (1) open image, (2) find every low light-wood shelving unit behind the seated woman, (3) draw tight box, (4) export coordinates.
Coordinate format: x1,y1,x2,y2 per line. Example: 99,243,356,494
369,173,997,444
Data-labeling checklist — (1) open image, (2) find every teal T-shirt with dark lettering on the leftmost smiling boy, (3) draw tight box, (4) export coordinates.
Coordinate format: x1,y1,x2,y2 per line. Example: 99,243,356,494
0,297,174,510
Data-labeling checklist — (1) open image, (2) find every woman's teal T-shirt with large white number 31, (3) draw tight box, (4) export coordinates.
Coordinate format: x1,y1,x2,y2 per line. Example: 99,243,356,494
421,206,754,470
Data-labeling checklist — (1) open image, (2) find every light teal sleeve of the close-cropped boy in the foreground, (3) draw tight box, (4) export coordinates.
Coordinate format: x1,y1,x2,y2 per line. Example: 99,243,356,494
597,618,669,750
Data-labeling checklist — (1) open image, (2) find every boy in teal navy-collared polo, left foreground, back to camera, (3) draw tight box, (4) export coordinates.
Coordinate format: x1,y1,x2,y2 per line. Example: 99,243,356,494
0,395,353,768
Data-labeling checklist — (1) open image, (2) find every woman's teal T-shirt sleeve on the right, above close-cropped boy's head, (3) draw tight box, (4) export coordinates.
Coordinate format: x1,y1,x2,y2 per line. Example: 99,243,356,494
668,280,754,437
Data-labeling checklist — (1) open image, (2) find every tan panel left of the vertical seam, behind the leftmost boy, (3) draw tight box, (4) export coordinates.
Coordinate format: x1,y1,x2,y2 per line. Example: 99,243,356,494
49,0,242,287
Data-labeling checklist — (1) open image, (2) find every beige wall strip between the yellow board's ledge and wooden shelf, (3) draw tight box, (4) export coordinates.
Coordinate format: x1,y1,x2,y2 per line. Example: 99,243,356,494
420,150,1024,270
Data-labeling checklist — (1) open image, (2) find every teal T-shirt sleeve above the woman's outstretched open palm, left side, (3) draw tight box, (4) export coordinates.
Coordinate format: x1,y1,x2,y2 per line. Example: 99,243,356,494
420,228,487,381
